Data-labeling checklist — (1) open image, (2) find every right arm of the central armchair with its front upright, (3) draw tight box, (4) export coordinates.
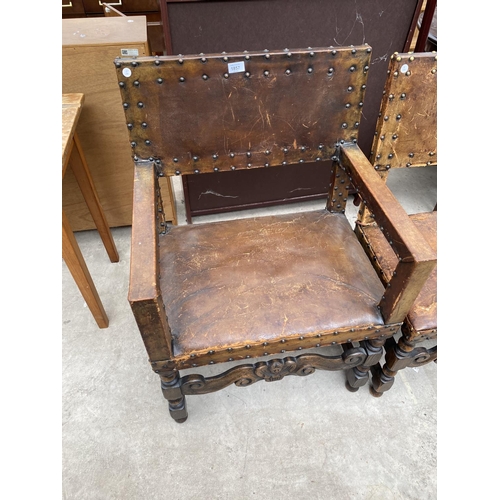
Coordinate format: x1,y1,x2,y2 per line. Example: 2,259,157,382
339,144,437,323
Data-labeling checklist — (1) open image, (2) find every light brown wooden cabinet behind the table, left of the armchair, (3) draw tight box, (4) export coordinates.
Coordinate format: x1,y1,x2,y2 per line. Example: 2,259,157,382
62,15,176,231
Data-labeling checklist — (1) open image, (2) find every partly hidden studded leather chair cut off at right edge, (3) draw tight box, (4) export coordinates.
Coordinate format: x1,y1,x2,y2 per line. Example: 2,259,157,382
355,52,437,396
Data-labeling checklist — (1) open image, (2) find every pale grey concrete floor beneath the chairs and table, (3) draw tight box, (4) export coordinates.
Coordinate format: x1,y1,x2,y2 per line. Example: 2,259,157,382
62,168,437,500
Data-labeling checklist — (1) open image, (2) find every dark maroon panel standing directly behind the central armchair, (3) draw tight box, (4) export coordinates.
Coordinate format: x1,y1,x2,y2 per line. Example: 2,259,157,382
160,0,422,221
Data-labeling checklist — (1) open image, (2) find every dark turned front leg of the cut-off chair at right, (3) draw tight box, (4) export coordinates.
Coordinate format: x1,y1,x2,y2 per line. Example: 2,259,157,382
370,337,415,398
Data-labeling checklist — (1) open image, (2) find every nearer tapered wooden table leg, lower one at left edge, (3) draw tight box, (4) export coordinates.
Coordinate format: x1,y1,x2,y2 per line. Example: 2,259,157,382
62,211,109,328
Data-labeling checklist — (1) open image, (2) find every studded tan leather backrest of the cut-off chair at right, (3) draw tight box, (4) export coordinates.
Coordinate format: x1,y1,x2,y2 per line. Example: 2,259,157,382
371,52,437,171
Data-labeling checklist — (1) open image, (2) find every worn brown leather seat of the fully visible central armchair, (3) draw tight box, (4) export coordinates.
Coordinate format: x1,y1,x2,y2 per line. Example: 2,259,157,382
160,210,384,356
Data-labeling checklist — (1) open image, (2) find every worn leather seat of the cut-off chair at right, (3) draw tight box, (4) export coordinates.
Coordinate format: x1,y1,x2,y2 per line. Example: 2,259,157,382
358,212,437,336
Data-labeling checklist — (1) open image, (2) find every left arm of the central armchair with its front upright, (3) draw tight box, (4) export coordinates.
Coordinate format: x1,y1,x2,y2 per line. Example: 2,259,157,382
128,162,172,361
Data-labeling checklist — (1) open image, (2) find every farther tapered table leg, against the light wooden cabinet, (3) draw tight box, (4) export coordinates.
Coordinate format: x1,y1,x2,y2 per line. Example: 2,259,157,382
69,133,119,262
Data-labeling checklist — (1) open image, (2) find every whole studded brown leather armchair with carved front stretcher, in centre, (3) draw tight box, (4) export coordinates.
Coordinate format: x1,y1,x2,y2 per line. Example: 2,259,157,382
115,46,435,422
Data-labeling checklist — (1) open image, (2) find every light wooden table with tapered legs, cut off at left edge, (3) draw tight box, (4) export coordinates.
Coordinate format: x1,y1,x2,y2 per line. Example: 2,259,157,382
62,94,119,328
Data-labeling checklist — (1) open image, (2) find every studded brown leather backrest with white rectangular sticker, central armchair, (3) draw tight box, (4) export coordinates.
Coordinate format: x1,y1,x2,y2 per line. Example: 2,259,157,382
115,45,371,175
